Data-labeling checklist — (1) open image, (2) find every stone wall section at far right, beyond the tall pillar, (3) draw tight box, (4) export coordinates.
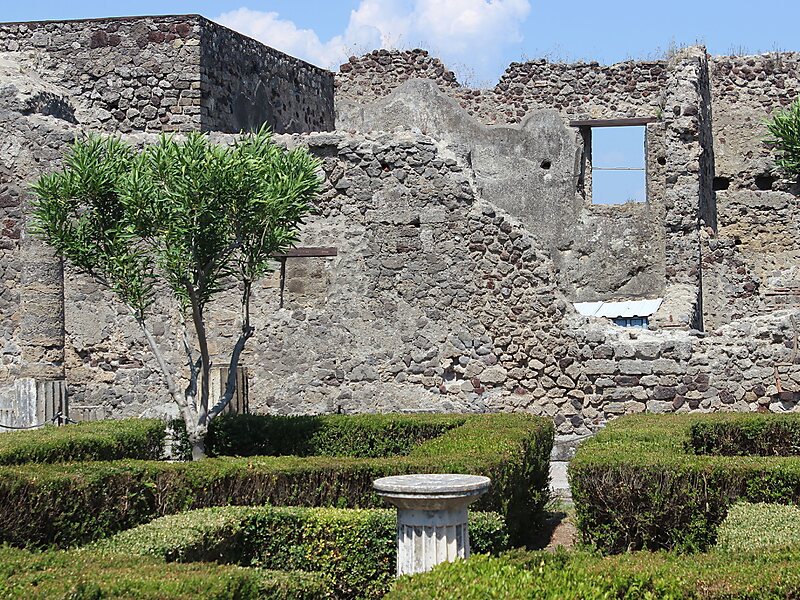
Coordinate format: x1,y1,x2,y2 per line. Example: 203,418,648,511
703,52,800,326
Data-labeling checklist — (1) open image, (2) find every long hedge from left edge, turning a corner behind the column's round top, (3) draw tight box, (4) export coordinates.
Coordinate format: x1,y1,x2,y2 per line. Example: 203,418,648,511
0,414,553,547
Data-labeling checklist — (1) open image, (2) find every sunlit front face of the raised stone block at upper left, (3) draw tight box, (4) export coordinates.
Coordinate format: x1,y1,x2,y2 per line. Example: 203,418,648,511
0,16,201,132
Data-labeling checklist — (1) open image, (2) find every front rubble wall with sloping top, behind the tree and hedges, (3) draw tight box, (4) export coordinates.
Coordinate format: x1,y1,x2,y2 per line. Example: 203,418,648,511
51,134,800,433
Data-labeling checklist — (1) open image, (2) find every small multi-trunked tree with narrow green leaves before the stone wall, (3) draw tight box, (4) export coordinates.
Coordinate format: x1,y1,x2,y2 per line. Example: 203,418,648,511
33,129,321,459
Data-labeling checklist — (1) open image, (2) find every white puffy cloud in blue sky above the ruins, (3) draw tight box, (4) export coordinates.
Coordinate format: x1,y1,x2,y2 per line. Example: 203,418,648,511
216,0,530,83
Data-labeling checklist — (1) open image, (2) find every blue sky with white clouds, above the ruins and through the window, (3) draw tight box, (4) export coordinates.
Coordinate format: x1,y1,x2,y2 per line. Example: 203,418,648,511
0,0,800,202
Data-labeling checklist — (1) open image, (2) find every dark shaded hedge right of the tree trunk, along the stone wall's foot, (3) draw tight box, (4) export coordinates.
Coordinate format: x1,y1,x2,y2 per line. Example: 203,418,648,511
206,414,465,458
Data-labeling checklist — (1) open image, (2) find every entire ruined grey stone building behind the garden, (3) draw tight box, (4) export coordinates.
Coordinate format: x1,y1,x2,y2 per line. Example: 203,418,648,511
0,16,800,433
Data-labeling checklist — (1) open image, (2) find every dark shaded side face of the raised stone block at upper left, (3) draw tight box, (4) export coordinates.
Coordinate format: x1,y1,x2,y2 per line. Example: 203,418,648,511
200,20,333,133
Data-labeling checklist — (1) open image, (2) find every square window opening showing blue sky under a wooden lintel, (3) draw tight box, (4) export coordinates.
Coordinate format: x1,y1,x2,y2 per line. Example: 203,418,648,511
581,125,647,204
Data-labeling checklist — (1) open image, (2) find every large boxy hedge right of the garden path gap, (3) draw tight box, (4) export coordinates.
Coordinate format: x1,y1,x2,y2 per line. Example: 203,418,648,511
569,414,800,552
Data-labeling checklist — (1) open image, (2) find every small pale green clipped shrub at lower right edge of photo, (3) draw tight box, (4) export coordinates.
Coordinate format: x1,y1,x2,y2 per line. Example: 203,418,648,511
716,502,800,552
